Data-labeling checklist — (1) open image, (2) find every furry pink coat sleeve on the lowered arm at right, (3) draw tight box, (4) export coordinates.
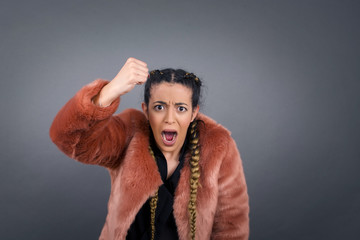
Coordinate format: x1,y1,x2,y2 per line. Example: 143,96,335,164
211,136,249,240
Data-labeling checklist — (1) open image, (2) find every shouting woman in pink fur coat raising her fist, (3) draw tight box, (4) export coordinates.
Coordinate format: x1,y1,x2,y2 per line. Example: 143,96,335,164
50,58,249,240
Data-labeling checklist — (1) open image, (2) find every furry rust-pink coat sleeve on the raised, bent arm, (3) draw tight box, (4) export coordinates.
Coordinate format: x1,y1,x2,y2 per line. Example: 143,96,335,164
50,79,130,168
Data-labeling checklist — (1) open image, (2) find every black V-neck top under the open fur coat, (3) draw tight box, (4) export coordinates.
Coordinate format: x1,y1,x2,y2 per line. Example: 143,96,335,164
126,136,187,240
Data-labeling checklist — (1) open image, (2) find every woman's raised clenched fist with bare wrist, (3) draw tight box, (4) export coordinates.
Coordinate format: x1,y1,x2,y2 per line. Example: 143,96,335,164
94,58,149,107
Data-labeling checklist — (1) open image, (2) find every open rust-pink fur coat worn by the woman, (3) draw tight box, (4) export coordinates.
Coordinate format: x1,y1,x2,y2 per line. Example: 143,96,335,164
50,79,249,240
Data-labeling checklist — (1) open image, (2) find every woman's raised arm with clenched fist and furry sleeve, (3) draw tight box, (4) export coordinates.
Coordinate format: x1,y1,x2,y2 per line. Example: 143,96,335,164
50,58,147,168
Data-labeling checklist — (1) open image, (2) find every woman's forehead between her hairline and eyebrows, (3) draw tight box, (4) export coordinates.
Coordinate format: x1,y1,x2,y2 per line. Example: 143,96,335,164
150,82,192,103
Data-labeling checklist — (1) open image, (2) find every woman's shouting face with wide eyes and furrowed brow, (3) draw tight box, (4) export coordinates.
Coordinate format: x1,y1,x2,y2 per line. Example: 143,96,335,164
142,82,199,157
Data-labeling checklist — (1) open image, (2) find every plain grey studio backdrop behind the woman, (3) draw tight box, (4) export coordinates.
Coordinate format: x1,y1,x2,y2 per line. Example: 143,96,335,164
0,0,360,240
